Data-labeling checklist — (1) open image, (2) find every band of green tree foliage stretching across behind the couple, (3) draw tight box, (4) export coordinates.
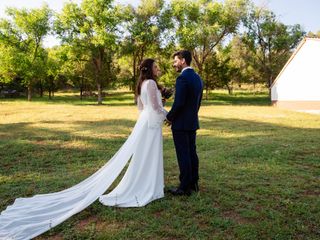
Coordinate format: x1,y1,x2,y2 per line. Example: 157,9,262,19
0,0,317,99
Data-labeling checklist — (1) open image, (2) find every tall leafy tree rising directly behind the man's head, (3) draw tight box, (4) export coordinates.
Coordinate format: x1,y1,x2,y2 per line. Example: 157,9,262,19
172,0,247,98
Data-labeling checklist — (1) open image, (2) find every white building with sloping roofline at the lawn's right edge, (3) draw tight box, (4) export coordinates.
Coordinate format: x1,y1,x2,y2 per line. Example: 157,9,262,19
271,38,320,110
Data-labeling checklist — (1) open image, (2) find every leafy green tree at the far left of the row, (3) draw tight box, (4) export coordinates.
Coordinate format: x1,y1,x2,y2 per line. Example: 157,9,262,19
0,5,51,101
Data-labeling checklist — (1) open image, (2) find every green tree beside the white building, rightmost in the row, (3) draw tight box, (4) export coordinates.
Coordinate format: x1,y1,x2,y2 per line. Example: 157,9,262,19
242,6,305,93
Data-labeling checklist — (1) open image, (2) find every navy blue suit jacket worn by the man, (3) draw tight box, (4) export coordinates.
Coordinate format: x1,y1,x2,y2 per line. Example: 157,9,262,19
167,68,203,131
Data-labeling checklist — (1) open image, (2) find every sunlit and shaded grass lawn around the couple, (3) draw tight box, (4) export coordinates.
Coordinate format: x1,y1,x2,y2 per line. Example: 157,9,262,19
0,91,320,240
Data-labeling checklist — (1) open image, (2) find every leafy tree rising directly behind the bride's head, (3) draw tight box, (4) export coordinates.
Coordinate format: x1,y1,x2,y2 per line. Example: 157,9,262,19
121,0,170,90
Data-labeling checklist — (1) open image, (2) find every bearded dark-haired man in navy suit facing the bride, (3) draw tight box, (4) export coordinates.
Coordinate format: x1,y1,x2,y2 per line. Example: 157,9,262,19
166,50,203,195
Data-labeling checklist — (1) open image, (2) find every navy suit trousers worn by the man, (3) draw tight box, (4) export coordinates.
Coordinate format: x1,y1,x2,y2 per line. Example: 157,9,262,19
172,130,199,190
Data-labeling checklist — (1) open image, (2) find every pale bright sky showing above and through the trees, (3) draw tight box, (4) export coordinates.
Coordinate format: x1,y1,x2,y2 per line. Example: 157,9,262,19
0,0,320,46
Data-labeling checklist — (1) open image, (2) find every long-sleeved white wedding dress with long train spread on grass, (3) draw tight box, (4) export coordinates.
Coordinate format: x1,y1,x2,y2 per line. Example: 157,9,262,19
0,80,167,240
